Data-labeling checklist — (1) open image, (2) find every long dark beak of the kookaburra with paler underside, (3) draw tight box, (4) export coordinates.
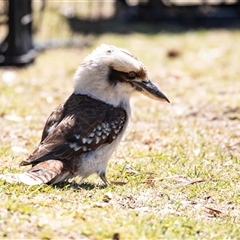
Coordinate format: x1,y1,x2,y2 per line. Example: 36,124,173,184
133,80,170,103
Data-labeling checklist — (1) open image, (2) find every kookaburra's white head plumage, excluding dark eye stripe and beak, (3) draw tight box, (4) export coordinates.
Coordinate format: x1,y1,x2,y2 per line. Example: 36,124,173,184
74,44,148,109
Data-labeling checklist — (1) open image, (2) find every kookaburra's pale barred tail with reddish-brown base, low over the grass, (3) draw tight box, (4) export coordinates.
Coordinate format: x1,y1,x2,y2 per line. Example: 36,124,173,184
0,160,70,185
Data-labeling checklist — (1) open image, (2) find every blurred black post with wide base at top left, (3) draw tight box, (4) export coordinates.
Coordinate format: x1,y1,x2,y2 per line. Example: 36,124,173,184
0,0,36,66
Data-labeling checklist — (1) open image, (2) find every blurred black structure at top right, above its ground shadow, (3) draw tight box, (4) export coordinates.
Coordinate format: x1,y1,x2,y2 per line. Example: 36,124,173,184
124,0,240,23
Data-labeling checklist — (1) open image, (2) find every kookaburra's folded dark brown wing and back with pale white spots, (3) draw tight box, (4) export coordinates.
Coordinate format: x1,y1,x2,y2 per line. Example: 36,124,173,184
20,94,127,166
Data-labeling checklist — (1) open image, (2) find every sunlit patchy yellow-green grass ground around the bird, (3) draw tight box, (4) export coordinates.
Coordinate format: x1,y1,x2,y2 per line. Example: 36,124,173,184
0,2,240,239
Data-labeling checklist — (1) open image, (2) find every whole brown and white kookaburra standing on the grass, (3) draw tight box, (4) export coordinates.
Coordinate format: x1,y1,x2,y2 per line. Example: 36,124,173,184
0,45,169,185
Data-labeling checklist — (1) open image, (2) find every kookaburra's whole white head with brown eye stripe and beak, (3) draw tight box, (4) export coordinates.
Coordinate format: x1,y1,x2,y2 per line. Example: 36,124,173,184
74,44,169,106
